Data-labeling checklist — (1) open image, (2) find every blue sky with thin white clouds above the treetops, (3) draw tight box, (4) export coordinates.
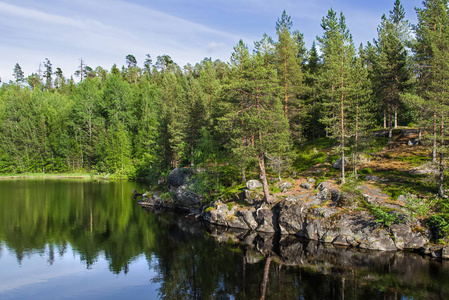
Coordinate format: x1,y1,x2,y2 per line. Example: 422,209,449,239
0,0,422,82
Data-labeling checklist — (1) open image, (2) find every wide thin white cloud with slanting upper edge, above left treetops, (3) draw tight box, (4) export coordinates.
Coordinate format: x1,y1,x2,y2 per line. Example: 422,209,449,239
0,0,242,81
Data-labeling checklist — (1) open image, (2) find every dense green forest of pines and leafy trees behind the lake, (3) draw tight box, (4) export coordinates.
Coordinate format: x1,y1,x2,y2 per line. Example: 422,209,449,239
0,0,449,200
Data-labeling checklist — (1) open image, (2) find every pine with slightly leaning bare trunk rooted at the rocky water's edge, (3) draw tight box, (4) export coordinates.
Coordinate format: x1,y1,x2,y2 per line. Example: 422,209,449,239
221,41,288,203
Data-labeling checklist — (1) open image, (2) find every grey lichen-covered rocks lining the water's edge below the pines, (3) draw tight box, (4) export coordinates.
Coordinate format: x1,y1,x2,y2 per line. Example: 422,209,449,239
139,168,449,259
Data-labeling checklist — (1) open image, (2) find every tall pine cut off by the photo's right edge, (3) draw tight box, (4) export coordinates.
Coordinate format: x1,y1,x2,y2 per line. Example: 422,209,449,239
414,0,449,197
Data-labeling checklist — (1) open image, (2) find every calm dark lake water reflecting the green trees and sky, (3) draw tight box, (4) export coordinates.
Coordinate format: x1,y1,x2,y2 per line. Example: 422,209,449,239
0,180,449,299
